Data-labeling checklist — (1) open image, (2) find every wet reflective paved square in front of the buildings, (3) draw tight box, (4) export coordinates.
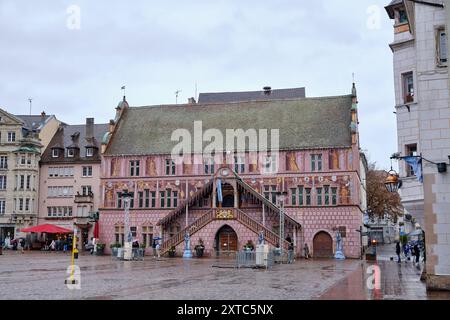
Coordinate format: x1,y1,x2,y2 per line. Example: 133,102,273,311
0,251,450,300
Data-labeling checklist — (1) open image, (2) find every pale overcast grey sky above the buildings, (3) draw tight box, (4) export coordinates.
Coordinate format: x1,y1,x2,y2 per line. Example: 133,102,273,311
0,0,397,168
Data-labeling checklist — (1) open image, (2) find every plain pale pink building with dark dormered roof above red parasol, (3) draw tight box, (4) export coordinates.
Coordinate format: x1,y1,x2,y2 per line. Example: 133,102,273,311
38,118,108,248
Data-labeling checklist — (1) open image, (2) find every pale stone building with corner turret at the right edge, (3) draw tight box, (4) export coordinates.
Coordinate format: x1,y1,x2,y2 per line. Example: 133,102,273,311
386,0,450,289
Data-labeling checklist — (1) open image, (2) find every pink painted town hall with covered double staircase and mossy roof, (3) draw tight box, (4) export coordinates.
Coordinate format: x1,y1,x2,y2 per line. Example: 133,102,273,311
100,87,365,258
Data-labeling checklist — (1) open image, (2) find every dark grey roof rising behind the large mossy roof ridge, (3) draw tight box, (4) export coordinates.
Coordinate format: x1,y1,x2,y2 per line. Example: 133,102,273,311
198,88,305,103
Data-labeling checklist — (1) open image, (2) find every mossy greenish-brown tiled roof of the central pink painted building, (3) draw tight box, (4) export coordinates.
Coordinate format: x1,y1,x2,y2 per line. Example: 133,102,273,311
105,95,352,155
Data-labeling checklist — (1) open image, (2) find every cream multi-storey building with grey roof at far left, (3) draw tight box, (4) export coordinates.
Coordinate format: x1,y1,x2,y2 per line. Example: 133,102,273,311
0,109,60,243
